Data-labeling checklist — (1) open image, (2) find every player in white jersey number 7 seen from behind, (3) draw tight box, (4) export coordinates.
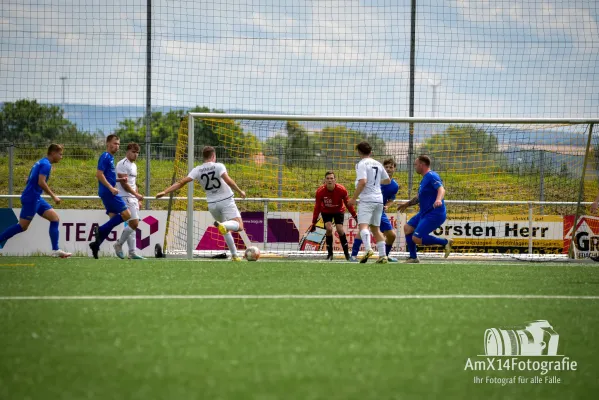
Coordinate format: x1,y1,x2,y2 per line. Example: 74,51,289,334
347,142,391,264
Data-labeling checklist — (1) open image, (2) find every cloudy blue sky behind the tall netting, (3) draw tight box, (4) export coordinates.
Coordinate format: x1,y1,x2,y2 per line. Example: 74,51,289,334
0,0,599,117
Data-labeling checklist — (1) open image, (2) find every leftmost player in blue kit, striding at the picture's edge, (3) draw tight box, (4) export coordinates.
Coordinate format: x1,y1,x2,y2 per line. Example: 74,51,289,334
0,144,71,258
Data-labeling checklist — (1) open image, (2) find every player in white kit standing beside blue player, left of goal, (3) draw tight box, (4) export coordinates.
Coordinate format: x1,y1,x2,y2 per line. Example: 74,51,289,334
114,143,144,260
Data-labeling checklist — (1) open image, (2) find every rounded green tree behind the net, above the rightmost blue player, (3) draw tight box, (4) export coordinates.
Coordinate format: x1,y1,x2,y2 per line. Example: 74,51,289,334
417,125,506,172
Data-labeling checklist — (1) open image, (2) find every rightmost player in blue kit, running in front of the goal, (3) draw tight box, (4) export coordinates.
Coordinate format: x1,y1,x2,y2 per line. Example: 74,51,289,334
398,156,452,263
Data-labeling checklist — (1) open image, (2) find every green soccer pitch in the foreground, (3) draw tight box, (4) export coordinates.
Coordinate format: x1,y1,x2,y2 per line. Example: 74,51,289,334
0,257,599,399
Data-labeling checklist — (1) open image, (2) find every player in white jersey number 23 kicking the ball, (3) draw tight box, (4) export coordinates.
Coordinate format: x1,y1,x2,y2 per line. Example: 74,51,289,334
156,146,245,261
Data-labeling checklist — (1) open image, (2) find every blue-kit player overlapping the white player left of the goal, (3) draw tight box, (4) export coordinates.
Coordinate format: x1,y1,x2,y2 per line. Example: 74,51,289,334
89,135,131,258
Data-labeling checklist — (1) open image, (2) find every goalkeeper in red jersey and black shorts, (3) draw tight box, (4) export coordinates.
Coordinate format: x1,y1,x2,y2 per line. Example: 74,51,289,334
310,171,357,261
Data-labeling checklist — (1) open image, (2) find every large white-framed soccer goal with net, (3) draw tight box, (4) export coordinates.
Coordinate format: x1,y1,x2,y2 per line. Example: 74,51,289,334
164,113,599,260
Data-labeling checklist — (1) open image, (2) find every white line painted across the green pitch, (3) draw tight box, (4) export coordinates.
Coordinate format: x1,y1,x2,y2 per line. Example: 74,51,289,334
0,294,599,301
